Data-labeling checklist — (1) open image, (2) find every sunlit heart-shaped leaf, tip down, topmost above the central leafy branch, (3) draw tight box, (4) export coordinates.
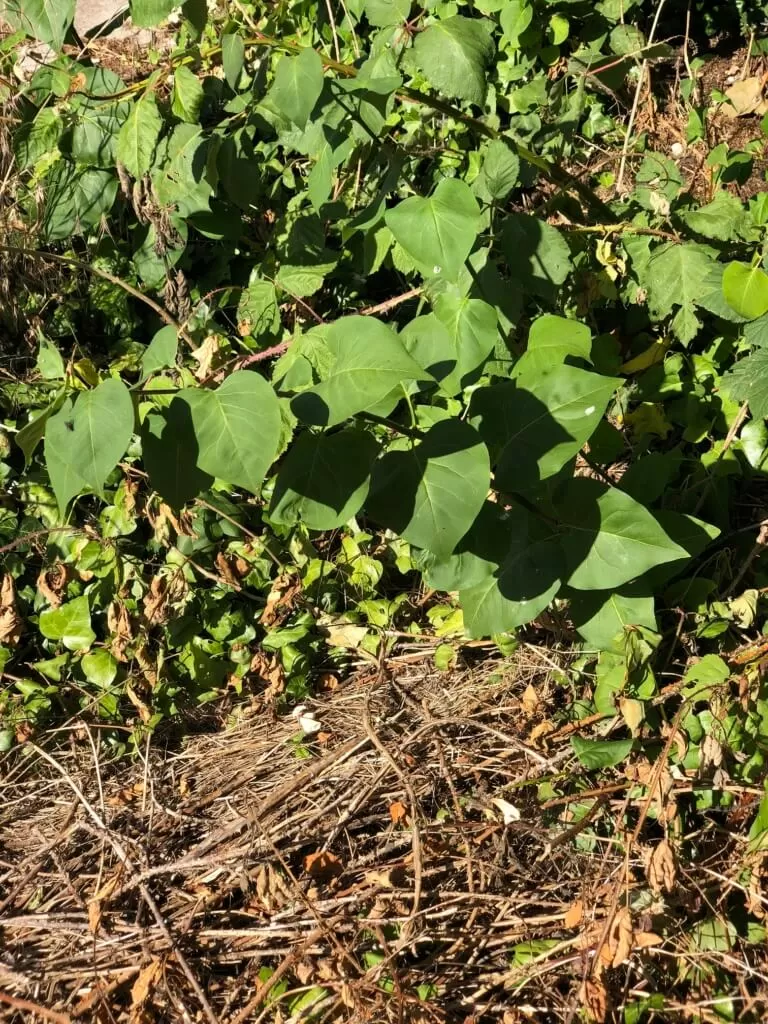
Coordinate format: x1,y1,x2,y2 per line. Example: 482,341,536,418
384,178,481,281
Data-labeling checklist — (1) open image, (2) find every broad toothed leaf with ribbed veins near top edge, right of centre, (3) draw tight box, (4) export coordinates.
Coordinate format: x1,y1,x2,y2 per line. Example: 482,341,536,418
414,14,494,106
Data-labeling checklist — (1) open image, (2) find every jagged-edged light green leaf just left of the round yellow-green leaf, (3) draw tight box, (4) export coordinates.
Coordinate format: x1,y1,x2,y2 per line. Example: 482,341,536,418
641,242,712,343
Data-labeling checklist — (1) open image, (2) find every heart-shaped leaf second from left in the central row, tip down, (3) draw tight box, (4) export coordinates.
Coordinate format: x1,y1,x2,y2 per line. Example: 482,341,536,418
179,370,282,494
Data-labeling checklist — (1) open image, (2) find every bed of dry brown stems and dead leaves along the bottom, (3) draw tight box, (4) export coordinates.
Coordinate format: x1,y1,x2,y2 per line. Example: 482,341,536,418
0,652,768,1024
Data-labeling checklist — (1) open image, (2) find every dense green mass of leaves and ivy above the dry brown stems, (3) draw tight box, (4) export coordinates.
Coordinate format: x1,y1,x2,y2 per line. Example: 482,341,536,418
0,0,768,742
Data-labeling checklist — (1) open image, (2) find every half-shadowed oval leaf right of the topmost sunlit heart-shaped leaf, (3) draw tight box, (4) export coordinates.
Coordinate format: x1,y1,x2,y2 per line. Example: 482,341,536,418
501,213,571,301
